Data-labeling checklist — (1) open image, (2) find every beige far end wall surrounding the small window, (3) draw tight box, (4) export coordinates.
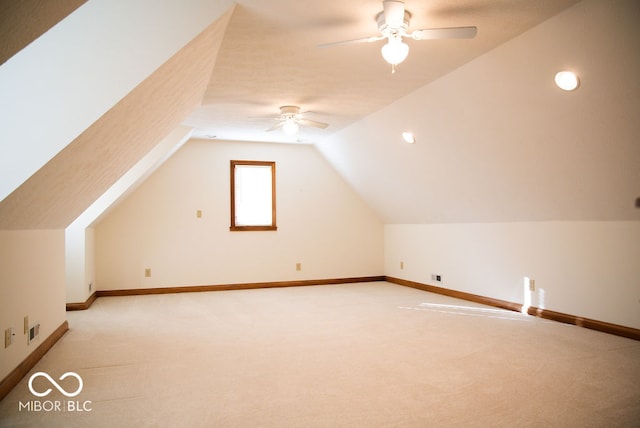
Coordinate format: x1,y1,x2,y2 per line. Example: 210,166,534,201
95,140,383,290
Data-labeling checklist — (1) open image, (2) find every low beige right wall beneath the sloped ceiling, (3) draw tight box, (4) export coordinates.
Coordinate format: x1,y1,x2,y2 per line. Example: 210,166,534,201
385,221,640,328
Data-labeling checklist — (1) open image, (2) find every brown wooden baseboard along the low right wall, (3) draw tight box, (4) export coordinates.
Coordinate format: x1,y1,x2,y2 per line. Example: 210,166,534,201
386,276,640,340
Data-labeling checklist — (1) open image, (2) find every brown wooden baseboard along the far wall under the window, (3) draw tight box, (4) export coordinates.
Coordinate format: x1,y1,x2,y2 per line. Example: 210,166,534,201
96,276,385,297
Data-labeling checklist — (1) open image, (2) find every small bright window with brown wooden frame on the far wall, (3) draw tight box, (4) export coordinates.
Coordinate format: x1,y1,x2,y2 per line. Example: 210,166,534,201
229,160,277,231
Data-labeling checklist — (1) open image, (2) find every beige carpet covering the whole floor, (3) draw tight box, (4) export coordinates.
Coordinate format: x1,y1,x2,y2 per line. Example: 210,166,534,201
0,282,640,427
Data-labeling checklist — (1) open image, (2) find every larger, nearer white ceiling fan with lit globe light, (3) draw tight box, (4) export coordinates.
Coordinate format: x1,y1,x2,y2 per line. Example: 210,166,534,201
319,0,478,73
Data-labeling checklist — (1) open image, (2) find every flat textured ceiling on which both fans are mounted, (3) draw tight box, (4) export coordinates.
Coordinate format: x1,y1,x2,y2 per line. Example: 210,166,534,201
183,0,577,143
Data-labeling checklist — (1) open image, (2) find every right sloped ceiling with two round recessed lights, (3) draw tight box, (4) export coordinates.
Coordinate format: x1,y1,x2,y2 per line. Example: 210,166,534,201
318,0,640,224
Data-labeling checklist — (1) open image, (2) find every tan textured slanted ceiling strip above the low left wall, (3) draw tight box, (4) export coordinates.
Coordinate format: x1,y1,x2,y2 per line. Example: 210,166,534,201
0,10,232,229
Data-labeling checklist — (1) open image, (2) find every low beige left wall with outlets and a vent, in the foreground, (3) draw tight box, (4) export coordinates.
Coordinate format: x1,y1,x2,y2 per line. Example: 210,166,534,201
0,230,65,379
